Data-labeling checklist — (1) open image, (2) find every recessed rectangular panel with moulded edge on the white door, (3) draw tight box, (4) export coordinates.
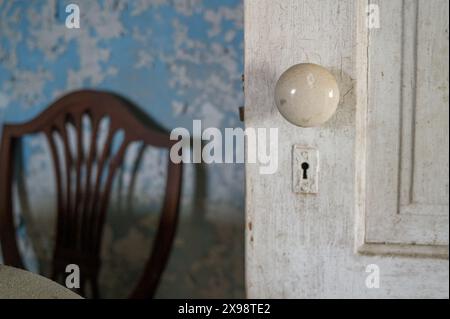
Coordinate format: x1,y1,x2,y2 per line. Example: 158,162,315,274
357,0,449,257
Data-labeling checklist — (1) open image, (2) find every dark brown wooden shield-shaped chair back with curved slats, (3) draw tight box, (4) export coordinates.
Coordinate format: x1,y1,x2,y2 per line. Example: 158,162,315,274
0,90,182,298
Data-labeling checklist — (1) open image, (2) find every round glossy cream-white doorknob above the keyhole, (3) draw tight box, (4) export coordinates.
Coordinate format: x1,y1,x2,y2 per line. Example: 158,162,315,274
275,63,339,127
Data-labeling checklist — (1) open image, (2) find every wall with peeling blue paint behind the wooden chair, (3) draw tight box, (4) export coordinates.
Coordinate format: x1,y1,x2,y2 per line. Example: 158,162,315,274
0,0,244,298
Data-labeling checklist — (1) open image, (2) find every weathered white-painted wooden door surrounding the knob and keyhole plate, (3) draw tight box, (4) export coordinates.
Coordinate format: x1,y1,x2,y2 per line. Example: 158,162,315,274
245,0,449,298
